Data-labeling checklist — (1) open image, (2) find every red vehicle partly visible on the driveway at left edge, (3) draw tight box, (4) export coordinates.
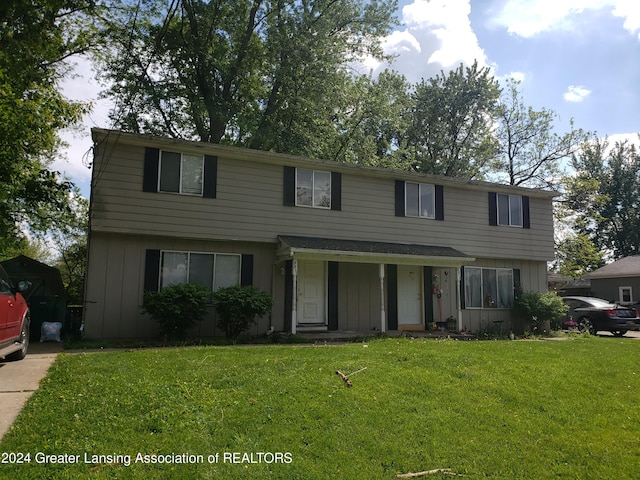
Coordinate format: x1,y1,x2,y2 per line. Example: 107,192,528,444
0,266,31,360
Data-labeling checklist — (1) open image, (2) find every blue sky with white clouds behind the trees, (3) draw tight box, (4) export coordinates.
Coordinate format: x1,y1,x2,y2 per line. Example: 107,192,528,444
54,0,640,197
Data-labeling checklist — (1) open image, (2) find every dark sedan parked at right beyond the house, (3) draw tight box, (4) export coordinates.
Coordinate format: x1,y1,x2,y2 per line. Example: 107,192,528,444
563,297,640,336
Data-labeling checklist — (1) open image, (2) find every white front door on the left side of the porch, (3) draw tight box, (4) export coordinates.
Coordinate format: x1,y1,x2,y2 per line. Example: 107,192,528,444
297,261,327,326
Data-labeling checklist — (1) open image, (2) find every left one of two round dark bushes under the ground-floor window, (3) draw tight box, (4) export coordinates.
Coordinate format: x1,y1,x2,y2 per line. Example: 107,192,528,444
143,283,209,339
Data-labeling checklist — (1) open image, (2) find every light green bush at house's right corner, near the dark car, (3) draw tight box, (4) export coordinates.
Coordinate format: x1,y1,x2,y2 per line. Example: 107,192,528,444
513,292,569,332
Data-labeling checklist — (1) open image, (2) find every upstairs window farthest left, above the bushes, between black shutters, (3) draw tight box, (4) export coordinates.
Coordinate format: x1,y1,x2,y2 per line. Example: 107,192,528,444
158,151,204,195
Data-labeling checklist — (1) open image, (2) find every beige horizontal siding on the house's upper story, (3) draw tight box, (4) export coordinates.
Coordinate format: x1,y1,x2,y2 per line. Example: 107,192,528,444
91,131,553,260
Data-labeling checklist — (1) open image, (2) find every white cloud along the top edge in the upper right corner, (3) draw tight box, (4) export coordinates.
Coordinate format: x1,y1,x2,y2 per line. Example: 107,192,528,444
493,0,640,38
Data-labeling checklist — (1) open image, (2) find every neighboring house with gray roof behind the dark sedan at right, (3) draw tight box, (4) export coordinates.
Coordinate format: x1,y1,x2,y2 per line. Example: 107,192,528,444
585,255,640,305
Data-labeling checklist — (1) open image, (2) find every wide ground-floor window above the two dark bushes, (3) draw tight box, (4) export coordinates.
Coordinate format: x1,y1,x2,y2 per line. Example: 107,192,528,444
160,251,241,292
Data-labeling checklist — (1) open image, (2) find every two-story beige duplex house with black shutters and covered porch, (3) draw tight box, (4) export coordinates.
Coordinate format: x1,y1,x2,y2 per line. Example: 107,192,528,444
85,129,554,338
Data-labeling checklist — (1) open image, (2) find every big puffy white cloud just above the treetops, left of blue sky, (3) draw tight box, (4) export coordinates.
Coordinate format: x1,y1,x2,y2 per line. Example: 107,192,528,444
369,0,486,83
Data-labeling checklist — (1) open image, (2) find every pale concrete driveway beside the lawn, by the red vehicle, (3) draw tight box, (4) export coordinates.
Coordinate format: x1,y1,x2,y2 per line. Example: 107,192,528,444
0,343,62,440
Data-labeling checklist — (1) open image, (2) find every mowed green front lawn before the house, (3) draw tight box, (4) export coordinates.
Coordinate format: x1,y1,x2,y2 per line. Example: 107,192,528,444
0,337,640,480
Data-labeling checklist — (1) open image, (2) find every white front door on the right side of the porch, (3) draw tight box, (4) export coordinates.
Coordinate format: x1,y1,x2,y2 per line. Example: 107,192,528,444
398,265,424,330
